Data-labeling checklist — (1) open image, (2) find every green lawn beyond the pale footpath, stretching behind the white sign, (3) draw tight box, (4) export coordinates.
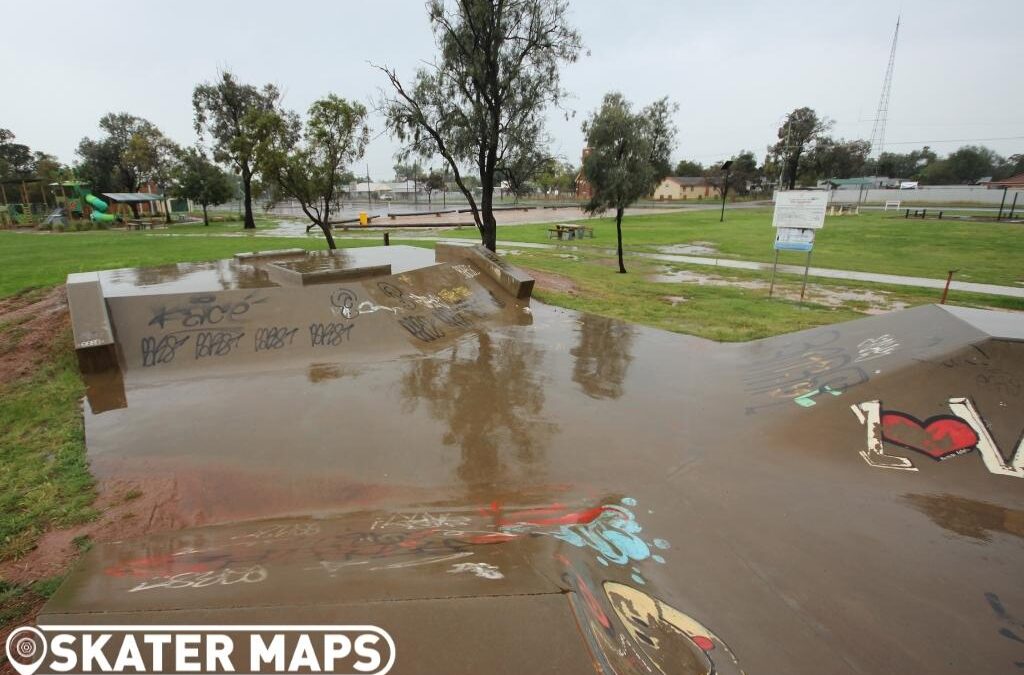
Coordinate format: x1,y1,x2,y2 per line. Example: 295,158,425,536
436,208,1024,286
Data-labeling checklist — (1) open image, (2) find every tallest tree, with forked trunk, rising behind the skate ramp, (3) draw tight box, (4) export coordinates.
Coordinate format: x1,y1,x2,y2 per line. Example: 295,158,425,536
378,0,582,250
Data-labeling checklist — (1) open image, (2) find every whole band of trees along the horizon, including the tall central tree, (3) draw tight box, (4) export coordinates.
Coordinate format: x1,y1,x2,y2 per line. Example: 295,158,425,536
0,0,1024,249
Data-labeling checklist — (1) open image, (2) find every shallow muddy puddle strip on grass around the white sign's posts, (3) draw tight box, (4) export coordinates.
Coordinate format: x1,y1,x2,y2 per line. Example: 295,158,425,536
647,267,908,314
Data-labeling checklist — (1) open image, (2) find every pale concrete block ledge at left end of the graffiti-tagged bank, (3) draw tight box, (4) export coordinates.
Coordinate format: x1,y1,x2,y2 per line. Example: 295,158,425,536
67,271,118,373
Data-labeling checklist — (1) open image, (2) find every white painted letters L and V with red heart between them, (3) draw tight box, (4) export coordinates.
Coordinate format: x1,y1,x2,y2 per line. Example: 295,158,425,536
850,397,1024,478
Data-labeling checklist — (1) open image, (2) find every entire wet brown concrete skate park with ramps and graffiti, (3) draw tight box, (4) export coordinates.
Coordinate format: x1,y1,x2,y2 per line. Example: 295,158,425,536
39,246,1024,674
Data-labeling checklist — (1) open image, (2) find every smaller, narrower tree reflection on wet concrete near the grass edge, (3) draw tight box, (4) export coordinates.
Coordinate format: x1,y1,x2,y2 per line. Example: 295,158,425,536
569,314,636,398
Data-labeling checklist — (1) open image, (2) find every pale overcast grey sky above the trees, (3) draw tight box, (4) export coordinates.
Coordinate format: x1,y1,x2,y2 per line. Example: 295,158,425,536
0,0,1024,179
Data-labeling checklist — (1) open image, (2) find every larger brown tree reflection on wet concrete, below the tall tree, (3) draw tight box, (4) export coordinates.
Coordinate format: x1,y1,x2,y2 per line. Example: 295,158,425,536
401,333,556,499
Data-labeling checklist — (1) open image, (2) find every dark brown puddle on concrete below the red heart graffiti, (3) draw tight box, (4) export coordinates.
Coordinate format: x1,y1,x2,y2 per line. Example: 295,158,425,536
903,494,1024,542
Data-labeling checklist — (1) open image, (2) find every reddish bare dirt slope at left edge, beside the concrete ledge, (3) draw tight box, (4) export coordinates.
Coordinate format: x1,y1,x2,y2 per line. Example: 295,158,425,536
0,286,71,386
